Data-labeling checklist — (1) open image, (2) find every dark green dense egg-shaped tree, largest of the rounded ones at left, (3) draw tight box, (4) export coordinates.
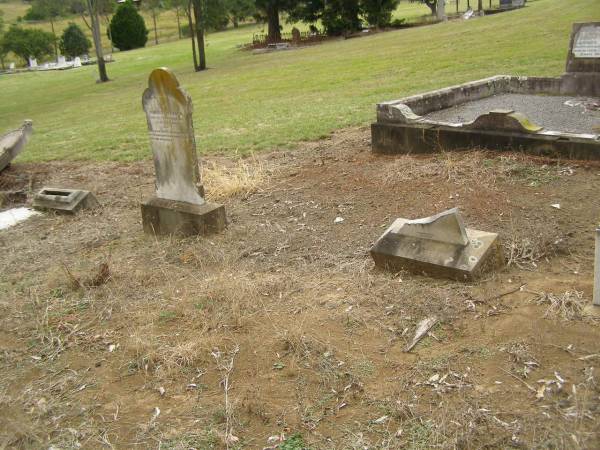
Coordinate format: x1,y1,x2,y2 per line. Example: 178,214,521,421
109,0,148,51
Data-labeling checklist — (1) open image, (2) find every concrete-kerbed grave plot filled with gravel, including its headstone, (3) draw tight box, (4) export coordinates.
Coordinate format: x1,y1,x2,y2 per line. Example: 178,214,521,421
371,22,600,160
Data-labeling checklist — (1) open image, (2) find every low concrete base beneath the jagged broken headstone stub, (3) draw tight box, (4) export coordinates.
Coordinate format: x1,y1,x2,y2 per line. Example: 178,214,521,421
371,219,504,281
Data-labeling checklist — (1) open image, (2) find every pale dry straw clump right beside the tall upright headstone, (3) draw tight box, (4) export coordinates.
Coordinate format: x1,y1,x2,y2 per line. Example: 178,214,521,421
202,158,267,199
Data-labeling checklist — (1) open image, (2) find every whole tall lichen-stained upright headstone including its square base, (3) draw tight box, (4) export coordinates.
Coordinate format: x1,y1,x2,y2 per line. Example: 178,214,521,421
142,68,226,235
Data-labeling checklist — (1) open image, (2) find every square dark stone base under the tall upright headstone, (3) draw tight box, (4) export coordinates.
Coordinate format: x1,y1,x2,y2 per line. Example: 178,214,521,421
142,197,227,236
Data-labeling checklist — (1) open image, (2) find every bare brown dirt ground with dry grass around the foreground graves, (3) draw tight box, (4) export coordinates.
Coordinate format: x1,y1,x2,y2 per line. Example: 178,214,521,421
0,127,600,449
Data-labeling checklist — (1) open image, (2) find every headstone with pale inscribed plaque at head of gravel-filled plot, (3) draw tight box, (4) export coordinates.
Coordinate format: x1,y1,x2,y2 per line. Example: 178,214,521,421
562,22,600,96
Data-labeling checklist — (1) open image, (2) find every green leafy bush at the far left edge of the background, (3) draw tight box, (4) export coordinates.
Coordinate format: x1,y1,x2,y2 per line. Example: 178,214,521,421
2,25,54,63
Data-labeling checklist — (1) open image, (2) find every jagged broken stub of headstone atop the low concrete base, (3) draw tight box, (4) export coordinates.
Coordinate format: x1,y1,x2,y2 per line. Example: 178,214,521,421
394,208,469,247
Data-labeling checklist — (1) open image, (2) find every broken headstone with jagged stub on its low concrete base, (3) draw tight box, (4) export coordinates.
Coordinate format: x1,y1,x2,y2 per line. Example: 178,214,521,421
371,208,504,281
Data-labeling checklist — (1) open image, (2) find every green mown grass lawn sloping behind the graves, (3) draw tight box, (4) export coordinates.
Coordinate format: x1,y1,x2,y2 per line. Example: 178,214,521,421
0,0,600,161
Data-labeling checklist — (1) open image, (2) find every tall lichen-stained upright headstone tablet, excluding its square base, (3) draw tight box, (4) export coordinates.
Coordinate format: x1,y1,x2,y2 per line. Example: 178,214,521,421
142,68,204,205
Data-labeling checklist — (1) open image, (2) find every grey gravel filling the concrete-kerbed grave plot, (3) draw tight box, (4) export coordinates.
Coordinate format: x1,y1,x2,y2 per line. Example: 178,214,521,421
425,94,600,134
